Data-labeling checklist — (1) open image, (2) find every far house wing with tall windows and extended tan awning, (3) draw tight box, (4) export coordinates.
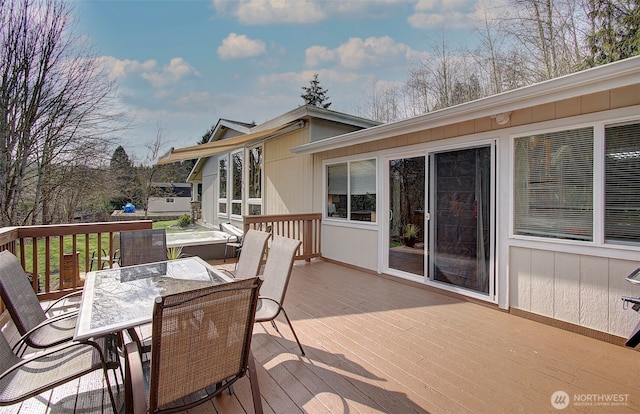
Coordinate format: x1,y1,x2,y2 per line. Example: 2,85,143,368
159,105,379,227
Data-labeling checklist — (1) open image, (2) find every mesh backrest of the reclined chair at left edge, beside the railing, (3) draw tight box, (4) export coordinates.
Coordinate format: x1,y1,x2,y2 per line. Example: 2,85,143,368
0,250,47,335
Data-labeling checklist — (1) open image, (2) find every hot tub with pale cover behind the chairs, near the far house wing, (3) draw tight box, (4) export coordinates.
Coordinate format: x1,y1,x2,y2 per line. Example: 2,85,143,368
167,230,236,260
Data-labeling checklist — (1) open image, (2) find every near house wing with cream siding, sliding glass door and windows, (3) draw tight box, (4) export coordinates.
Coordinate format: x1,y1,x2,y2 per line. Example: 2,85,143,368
289,57,640,337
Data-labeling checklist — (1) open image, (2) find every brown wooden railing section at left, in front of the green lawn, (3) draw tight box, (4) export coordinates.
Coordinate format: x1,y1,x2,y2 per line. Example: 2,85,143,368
0,220,152,308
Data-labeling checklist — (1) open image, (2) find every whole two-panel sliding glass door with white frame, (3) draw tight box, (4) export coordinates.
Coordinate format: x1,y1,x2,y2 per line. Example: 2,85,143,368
386,145,494,295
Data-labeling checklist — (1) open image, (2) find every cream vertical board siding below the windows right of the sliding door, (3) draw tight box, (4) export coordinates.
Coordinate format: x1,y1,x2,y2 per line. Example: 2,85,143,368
509,246,640,337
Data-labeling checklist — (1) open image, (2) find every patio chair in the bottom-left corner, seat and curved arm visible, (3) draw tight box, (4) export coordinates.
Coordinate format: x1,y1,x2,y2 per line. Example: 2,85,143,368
0,333,119,413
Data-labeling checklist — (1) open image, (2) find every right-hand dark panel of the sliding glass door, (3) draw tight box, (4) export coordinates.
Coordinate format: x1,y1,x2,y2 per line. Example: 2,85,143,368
430,147,493,294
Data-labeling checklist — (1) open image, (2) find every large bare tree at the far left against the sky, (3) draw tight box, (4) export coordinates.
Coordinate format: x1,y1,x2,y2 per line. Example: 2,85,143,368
0,0,118,225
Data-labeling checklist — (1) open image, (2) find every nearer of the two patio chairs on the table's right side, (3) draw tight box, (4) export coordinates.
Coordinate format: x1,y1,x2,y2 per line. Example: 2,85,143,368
256,236,304,355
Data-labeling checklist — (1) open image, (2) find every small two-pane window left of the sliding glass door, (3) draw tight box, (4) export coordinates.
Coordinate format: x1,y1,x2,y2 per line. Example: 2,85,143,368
326,160,376,222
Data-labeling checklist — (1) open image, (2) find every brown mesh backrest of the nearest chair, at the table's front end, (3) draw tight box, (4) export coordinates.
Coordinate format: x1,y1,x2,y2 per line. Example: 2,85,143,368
149,277,261,412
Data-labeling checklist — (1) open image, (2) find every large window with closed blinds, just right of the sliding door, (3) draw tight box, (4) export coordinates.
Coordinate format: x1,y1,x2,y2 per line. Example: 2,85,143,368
514,128,594,241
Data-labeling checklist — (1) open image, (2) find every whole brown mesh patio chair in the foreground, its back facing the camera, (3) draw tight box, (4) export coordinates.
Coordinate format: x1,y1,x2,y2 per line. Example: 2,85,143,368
125,277,262,413
